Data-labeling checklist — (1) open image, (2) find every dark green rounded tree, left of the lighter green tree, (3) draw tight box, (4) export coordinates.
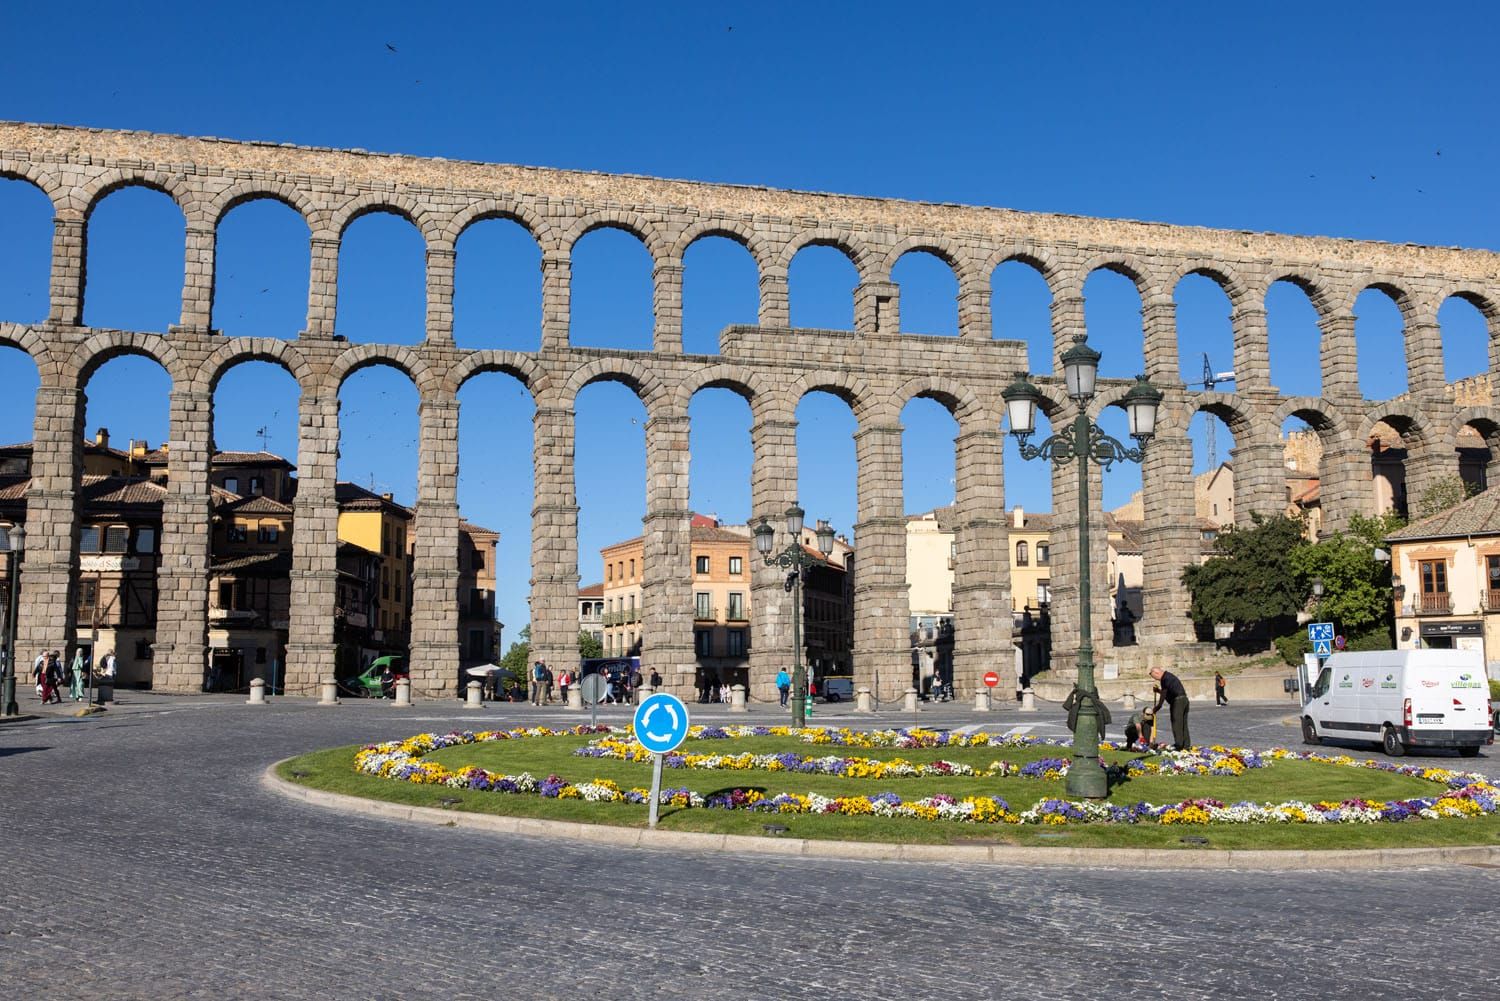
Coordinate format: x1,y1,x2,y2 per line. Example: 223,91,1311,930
1182,515,1304,630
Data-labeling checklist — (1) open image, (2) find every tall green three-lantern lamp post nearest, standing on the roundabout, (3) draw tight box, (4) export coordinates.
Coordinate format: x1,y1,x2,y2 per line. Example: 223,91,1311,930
1001,333,1161,800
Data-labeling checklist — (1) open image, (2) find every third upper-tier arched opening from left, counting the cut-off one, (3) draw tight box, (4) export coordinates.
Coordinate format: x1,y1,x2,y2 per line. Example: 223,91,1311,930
213,198,312,338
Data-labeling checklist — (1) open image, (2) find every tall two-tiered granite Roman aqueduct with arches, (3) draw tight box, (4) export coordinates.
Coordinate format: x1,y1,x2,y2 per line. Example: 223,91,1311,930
0,123,1500,696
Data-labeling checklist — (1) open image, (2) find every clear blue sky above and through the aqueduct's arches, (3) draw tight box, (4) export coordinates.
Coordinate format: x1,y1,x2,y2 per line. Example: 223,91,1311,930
0,2,1500,636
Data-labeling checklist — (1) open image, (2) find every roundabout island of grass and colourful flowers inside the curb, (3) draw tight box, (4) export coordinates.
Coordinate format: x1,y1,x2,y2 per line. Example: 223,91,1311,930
276,725,1500,857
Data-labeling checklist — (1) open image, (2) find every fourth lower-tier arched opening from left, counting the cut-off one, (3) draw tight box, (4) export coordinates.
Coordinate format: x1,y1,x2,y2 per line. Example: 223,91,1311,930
335,362,422,672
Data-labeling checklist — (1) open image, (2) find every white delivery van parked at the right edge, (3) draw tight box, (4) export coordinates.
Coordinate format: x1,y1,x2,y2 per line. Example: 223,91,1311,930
1302,650,1494,758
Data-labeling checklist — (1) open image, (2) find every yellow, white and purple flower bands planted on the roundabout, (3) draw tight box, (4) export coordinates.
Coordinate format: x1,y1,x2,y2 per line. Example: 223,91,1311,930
356,725,1500,825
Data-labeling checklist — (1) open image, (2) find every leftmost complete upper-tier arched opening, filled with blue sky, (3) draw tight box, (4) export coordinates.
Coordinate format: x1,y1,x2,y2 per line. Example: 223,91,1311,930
84,185,188,333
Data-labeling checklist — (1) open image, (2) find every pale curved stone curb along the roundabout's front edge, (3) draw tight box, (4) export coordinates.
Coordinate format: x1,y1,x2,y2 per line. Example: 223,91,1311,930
261,758,1500,872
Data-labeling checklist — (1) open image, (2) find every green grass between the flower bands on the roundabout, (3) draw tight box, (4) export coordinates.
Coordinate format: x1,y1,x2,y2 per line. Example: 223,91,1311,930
281,735,1500,849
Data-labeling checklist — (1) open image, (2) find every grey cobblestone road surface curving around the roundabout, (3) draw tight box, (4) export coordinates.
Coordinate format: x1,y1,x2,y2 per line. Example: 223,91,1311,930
0,693,1500,1001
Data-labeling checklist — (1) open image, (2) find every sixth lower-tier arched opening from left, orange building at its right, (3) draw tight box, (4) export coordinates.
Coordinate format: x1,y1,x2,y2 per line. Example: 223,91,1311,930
573,381,645,657
